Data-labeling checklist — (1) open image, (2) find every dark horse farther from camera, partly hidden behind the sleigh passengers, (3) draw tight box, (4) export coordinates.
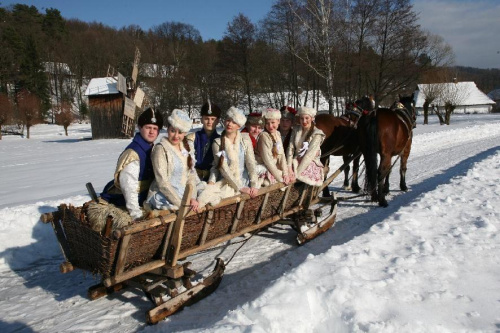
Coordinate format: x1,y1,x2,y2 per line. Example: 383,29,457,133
315,104,360,197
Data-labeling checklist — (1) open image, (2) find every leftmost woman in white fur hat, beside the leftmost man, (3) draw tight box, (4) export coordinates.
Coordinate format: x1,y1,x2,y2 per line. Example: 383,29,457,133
146,109,199,211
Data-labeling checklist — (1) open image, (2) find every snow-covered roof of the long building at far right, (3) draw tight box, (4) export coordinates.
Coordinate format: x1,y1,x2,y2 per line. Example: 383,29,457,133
415,81,495,108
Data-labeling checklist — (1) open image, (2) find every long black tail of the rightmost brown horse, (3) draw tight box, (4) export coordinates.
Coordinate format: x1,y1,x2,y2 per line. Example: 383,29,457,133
364,116,378,194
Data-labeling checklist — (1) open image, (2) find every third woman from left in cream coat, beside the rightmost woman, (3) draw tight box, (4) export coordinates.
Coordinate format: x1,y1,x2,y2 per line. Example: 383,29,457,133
255,109,290,186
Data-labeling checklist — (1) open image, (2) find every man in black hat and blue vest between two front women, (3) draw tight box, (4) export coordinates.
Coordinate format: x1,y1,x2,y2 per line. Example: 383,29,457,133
186,101,221,181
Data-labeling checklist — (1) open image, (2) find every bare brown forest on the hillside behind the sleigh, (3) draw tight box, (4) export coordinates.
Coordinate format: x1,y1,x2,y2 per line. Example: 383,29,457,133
0,0,500,126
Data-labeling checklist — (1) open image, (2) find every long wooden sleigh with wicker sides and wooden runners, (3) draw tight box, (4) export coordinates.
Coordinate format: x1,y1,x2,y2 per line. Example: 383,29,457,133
41,167,342,324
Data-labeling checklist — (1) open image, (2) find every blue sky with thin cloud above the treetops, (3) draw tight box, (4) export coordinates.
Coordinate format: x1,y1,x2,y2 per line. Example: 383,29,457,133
0,0,500,68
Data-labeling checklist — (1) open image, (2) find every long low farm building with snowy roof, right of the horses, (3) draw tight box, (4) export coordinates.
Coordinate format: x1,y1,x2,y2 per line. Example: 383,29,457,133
415,82,495,114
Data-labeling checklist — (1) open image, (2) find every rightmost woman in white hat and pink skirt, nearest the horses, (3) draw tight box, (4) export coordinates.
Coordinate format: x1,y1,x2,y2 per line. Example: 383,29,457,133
287,107,325,186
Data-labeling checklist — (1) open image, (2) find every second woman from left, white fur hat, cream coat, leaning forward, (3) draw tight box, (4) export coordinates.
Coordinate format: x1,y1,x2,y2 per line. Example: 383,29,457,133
199,107,259,205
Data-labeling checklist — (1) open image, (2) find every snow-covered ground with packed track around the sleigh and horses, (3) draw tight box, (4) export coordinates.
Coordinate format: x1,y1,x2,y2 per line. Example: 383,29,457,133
0,115,500,333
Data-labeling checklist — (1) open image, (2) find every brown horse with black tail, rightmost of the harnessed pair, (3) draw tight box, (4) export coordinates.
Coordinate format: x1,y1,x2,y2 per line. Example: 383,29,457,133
356,95,415,207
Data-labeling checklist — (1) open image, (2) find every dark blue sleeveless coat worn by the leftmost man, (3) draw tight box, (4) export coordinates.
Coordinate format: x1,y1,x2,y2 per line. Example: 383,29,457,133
101,133,155,206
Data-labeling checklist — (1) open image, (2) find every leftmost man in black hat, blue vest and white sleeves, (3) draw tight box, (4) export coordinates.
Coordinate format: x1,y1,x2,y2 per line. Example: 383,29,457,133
101,108,163,219
